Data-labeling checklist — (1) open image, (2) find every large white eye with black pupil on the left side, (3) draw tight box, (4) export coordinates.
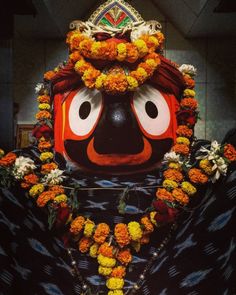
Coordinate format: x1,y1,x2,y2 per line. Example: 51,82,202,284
69,88,102,136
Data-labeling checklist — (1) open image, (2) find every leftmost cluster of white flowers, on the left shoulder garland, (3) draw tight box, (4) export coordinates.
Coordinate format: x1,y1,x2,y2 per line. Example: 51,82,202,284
13,156,36,179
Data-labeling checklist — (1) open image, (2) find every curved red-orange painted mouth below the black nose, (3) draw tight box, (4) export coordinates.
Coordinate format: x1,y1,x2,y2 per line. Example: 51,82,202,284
87,137,152,166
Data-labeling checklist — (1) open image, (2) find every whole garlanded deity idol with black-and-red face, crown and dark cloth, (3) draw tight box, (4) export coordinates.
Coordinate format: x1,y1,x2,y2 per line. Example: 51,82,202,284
0,0,236,295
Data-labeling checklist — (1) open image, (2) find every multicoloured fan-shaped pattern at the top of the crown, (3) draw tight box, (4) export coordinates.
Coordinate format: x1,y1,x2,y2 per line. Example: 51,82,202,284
89,0,143,28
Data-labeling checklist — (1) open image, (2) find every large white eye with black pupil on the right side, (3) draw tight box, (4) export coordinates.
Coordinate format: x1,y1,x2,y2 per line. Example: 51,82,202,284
133,85,170,136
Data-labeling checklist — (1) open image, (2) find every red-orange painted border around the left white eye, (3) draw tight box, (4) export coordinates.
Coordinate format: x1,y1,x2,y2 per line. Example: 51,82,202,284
62,87,104,140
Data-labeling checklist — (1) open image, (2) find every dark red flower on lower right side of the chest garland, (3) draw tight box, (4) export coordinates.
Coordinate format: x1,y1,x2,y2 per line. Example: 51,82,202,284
153,200,178,223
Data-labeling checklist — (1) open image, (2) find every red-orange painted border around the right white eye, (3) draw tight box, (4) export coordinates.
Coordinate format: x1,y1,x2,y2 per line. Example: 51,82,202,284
131,88,175,140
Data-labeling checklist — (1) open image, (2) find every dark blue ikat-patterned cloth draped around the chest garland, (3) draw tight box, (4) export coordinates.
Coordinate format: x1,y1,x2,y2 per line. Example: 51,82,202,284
0,150,236,295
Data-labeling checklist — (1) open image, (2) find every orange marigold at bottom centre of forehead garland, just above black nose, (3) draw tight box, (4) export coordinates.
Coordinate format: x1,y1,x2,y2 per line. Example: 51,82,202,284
104,73,128,93
